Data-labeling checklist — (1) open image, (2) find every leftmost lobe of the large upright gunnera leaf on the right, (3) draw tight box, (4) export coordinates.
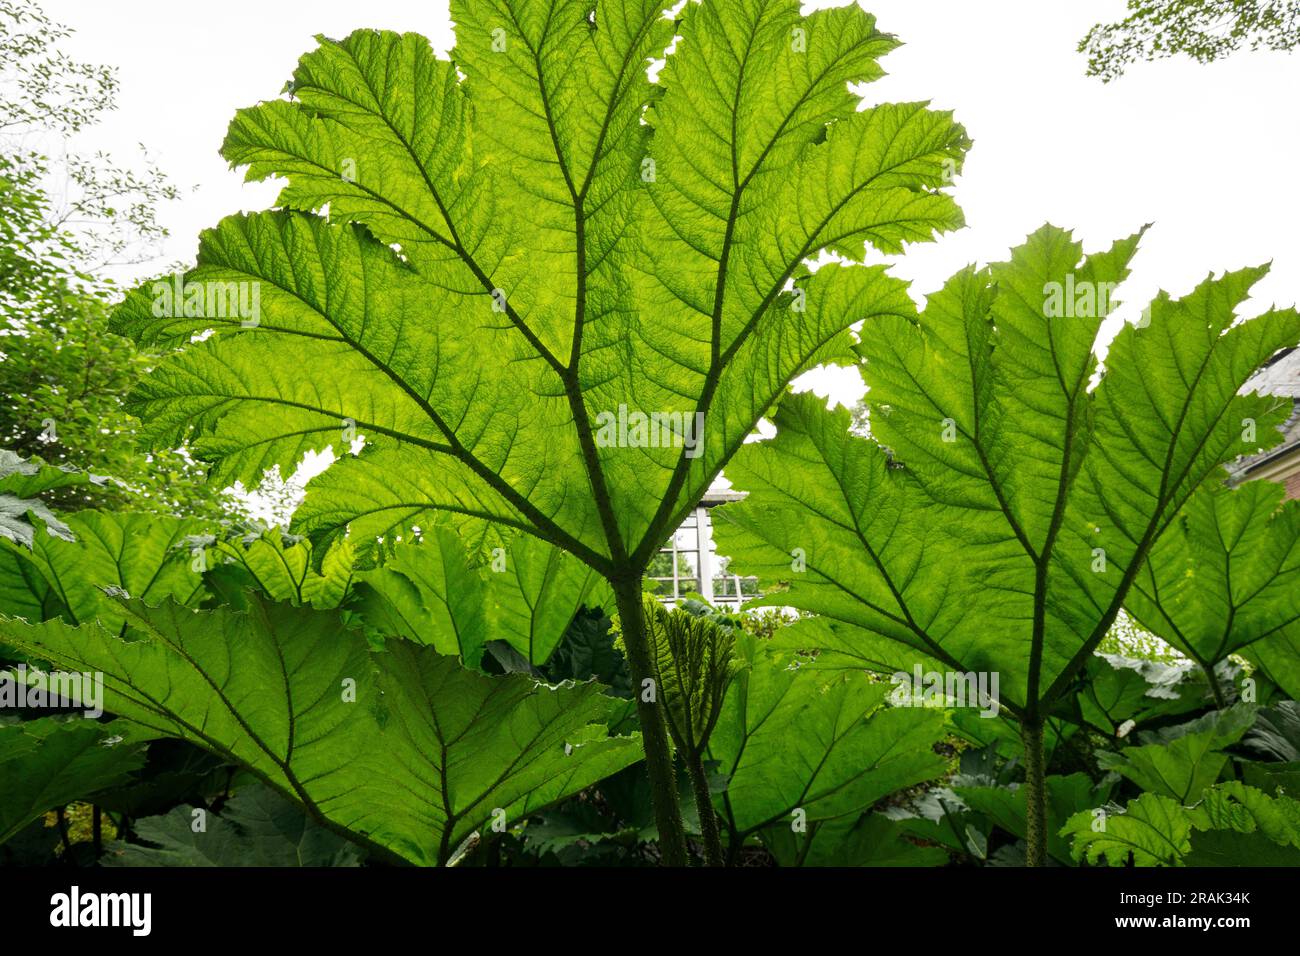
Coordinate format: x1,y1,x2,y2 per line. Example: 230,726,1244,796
714,393,966,674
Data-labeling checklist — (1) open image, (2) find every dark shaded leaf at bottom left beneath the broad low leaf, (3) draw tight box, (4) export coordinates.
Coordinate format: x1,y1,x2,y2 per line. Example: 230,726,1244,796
100,787,361,866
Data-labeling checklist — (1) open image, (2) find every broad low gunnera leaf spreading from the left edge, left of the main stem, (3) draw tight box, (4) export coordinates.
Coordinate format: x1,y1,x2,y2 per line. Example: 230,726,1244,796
0,597,640,864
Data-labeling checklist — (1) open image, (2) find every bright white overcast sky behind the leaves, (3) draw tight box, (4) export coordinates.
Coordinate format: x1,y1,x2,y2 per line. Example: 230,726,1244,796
42,0,1300,402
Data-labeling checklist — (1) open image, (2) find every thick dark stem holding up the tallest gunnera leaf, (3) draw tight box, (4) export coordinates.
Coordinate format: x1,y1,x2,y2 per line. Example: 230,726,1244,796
611,575,686,866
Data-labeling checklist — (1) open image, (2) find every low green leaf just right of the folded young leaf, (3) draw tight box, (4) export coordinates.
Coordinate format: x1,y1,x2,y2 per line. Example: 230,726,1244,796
707,635,945,836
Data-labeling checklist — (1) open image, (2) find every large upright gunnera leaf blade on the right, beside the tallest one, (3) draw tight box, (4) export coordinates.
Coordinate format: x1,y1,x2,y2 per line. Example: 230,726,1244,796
716,226,1300,714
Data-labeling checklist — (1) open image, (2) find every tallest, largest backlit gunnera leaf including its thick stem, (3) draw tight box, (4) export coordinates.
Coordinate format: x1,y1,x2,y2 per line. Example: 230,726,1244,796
114,0,969,864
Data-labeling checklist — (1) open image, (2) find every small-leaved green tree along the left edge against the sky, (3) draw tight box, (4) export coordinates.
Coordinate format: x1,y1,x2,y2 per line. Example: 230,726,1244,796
0,0,222,516
